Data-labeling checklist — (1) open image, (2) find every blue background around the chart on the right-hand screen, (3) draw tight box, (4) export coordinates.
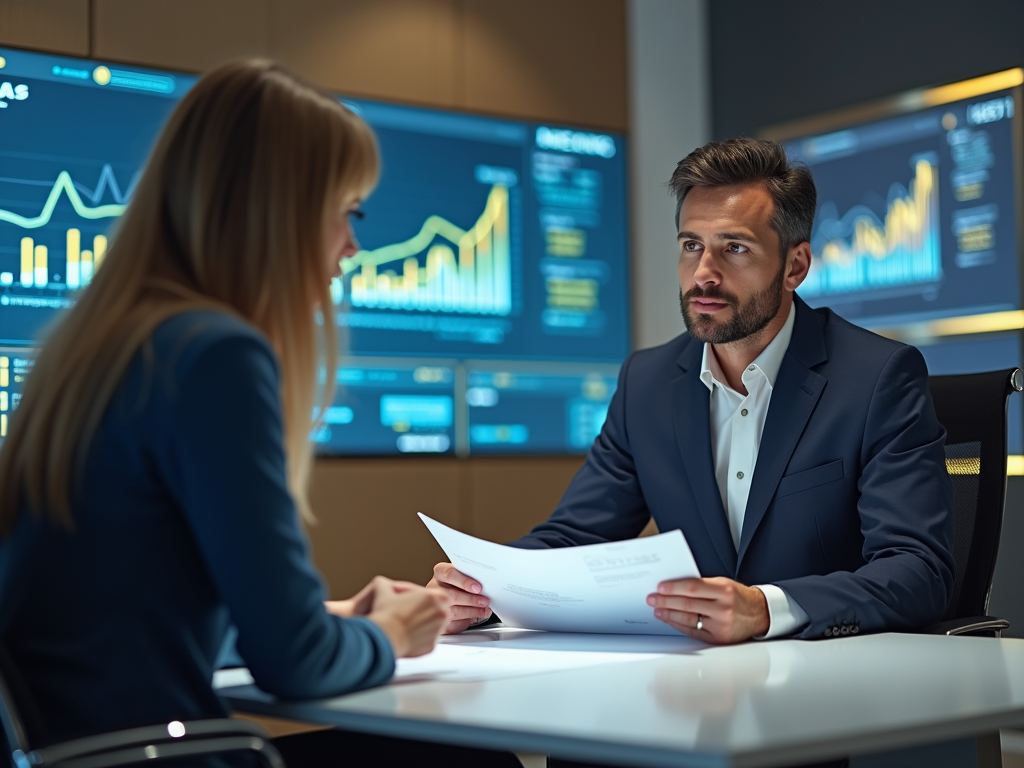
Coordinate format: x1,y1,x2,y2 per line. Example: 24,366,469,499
785,92,1021,326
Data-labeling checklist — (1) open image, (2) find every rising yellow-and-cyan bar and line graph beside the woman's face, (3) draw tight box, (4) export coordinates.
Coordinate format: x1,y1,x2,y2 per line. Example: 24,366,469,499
332,184,512,315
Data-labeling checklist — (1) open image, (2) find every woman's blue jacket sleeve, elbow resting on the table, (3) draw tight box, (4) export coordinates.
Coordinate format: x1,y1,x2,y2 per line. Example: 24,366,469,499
159,334,394,698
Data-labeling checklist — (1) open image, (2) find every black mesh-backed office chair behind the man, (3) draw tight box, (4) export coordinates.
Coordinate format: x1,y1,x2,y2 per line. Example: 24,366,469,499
926,368,1024,637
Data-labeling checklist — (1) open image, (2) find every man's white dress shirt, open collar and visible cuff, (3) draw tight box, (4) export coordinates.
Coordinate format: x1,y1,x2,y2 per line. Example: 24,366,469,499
700,304,809,639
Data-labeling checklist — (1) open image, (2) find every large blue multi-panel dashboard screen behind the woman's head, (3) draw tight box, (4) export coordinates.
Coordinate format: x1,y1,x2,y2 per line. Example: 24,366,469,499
0,48,630,455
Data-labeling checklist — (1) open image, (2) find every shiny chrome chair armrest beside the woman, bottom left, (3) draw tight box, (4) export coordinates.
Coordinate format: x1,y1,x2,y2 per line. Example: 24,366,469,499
29,718,285,768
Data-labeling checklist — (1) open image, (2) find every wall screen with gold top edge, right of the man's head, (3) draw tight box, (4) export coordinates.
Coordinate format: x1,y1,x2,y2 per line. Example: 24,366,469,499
783,70,1022,328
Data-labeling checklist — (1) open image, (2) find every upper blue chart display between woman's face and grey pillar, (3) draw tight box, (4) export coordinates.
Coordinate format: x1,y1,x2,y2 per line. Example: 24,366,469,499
334,98,629,362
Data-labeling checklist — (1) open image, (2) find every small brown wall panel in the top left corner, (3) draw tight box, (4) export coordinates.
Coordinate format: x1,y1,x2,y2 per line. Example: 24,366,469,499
0,0,89,56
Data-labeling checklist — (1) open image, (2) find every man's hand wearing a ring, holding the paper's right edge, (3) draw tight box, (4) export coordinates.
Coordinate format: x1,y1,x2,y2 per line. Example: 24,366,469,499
647,577,771,645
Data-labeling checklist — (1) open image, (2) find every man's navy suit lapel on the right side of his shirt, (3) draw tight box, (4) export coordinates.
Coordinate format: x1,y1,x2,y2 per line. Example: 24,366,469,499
737,296,828,568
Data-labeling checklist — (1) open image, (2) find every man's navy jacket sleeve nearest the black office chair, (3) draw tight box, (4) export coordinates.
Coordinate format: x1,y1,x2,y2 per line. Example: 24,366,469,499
776,346,953,638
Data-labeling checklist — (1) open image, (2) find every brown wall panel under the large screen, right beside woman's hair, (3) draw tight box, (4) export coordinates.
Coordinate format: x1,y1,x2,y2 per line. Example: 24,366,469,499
309,459,462,598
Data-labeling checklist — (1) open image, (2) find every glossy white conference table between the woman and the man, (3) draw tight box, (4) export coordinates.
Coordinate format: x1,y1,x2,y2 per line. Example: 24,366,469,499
220,630,1024,768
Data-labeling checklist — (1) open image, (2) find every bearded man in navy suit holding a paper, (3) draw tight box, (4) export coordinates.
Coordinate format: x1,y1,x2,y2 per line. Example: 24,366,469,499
432,139,953,643
